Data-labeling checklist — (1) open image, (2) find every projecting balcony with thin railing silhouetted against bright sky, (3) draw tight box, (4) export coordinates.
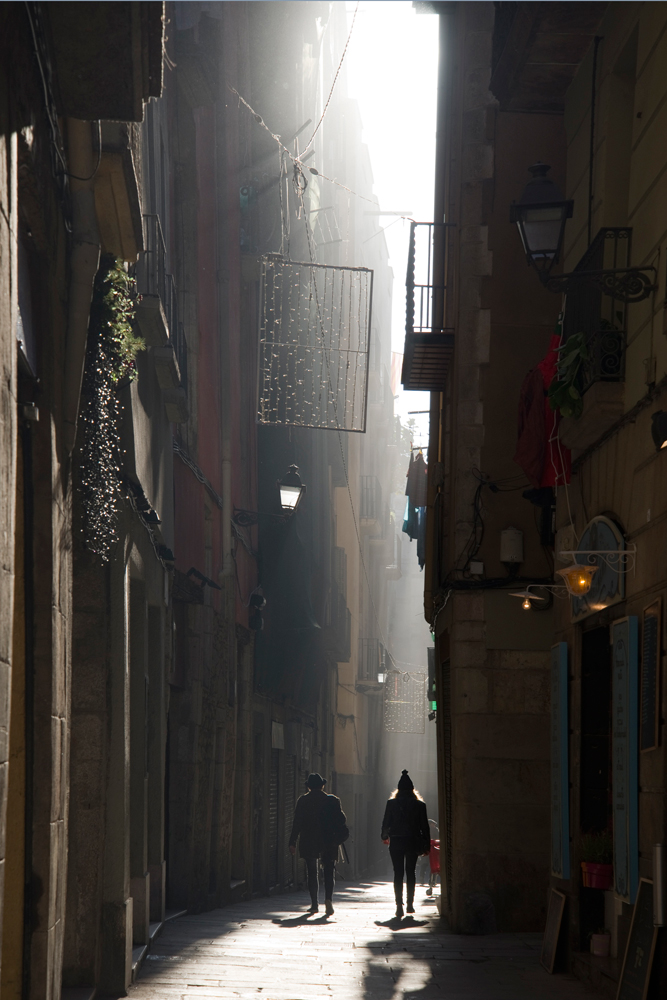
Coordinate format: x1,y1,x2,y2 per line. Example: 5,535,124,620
401,222,454,391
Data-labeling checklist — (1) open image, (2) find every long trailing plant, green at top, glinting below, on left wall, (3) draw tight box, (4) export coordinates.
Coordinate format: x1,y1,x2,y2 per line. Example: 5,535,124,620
79,255,145,562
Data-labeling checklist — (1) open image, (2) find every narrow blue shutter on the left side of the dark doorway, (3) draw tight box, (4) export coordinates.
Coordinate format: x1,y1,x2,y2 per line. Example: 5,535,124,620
551,642,570,878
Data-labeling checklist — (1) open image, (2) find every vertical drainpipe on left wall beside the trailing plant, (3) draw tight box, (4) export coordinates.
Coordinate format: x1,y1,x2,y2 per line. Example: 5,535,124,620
63,118,100,455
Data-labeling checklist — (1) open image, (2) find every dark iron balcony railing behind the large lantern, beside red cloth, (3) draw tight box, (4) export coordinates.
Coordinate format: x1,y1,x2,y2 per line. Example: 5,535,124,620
563,227,632,393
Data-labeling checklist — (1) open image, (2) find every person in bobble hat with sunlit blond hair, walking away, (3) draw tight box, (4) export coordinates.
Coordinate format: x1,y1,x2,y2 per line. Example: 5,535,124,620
381,771,431,917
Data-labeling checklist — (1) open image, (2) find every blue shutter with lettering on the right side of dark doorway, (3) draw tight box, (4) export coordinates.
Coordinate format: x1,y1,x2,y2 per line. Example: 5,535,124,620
611,615,639,903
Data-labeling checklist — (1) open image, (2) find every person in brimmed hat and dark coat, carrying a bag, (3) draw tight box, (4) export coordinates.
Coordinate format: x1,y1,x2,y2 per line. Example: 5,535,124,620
289,774,349,917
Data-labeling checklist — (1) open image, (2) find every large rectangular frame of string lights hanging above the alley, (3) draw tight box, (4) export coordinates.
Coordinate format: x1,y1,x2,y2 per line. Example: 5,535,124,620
257,257,373,432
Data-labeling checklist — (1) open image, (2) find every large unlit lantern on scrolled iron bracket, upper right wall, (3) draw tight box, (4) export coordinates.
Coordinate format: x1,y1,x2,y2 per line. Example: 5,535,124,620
510,162,657,302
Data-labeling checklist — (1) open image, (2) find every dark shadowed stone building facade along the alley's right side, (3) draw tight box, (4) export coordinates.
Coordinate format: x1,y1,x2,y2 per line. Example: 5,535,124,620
412,3,665,995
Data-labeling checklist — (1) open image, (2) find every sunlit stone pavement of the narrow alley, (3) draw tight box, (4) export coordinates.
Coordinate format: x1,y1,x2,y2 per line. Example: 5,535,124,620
129,881,594,1000
